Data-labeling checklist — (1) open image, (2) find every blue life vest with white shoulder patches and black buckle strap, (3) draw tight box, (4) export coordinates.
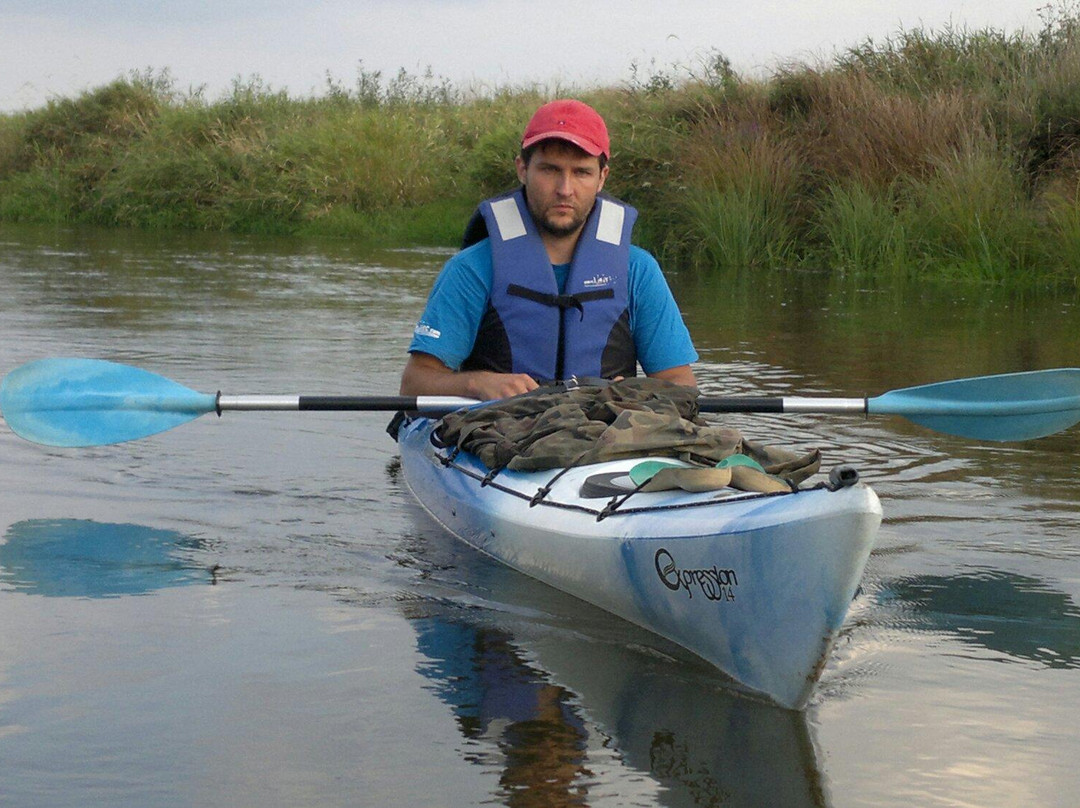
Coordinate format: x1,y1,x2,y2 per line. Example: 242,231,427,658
462,188,637,381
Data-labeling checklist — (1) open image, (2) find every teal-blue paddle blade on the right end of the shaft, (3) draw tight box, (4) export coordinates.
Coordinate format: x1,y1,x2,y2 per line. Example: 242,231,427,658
866,367,1080,441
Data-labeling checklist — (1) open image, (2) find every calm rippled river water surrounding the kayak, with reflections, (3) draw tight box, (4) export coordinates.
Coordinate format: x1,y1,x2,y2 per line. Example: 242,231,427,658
0,226,1080,808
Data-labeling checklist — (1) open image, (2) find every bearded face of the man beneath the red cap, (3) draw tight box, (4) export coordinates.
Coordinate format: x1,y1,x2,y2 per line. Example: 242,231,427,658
516,140,608,238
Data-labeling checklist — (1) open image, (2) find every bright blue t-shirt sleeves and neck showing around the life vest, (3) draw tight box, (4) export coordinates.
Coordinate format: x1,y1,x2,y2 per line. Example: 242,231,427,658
408,239,698,374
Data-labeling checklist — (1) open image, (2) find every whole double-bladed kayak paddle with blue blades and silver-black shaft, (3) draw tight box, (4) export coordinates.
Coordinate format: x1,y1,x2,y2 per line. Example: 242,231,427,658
6,359,1080,447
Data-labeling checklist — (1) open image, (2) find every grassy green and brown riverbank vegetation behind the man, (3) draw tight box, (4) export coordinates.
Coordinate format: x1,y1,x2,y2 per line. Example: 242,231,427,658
0,3,1080,288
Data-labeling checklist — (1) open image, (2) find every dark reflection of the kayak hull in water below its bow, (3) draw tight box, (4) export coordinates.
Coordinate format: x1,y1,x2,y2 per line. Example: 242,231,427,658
516,613,828,808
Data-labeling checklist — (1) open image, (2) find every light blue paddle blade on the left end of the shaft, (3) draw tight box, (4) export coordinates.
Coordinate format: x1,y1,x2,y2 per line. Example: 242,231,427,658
0,359,216,446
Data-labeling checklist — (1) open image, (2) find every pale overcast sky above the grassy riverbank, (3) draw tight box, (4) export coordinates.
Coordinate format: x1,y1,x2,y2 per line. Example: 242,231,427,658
0,0,1050,111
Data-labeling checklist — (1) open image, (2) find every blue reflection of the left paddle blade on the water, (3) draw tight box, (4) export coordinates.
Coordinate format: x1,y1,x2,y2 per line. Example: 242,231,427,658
0,519,215,597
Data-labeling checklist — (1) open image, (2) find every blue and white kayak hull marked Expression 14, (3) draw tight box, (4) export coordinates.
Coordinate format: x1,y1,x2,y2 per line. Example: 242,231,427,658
399,418,881,709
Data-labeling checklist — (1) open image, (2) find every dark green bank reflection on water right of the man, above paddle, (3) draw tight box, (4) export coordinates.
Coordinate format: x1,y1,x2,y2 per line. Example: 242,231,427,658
671,270,1080,388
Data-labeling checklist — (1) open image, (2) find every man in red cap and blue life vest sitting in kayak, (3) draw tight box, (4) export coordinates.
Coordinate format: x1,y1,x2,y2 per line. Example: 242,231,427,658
401,99,698,401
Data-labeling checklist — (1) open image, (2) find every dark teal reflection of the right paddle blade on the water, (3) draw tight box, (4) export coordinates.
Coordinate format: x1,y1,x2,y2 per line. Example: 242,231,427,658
879,569,1080,669
